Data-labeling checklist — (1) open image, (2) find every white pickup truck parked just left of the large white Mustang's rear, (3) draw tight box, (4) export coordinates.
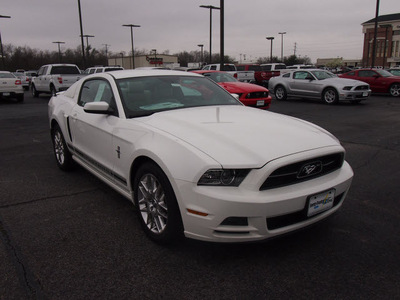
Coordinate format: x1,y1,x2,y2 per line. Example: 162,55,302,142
31,64,84,97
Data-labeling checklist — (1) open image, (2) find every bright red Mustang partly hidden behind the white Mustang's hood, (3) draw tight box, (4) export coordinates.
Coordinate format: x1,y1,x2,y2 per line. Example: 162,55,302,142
193,70,271,109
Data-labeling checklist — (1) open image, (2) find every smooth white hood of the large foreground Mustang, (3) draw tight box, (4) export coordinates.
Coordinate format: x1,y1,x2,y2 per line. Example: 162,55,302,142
141,106,339,168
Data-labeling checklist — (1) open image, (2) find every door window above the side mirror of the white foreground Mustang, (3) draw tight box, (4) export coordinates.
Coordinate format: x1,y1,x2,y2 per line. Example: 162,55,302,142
78,79,117,115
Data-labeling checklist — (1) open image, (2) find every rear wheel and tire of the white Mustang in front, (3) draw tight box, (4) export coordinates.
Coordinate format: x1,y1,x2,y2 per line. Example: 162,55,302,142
51,125,75,171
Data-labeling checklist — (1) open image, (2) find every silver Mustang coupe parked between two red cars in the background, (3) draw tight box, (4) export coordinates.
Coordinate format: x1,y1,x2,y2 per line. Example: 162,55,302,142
268,69,371,104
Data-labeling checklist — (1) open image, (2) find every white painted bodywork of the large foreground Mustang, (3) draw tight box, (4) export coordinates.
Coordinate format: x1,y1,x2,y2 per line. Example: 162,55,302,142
49,70,353,242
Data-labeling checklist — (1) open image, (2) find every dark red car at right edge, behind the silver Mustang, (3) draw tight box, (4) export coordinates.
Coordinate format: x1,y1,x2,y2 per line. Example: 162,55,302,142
339,69,400,97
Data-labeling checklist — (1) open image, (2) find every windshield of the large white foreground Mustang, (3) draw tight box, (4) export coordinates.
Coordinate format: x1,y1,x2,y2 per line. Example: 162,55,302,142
117,75,242,118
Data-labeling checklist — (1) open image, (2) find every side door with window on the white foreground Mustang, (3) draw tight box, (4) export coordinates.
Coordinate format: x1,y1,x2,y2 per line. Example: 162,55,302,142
70,78,119,177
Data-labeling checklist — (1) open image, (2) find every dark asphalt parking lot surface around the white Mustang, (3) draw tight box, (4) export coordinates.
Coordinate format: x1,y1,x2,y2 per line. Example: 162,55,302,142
0,92,400,299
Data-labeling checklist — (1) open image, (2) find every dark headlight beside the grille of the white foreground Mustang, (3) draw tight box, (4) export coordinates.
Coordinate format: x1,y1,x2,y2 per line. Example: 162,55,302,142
197,169,250,186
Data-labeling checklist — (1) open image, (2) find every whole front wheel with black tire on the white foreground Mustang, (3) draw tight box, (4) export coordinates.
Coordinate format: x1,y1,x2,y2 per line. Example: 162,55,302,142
133,162,183,244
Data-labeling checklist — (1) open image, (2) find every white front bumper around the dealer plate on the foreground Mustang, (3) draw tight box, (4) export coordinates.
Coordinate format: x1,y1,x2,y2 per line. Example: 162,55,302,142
176,149,353,242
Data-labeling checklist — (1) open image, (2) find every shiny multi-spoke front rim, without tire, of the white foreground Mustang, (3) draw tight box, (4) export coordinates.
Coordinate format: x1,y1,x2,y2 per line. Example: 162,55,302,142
138,174,168,234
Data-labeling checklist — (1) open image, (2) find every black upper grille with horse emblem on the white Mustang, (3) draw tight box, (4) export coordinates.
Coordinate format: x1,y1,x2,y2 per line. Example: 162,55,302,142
260,153,344,191
